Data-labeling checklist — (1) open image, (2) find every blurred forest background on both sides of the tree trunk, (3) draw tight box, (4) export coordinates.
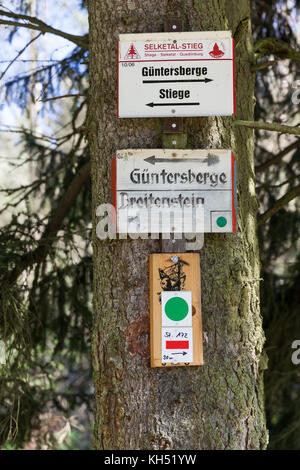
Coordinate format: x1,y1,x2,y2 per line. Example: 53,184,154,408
0,0,300,449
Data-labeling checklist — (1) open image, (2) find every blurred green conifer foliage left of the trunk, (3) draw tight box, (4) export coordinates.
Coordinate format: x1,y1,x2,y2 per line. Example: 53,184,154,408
0,2,92,448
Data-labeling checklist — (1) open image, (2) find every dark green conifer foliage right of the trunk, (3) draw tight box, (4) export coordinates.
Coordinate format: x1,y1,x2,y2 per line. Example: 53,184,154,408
253,0,300,450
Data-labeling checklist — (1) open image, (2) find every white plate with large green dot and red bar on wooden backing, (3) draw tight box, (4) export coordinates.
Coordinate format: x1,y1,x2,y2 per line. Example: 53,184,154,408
161,291,193,364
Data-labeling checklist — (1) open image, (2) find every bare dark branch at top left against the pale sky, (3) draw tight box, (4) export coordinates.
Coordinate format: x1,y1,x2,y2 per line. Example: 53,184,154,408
0,10,89,49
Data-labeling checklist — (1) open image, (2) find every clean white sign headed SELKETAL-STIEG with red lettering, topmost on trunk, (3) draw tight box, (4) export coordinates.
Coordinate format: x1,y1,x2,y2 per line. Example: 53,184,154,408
118,31,235,118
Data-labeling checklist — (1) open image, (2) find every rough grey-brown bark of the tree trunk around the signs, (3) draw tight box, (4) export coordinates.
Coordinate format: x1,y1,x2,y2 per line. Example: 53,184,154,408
88,0,267,449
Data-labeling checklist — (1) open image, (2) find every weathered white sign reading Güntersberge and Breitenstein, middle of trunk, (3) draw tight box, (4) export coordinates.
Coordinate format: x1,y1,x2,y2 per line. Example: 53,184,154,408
112,149,237,234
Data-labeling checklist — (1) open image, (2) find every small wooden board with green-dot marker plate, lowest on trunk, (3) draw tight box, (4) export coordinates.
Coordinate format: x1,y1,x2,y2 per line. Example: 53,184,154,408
150,253,203,367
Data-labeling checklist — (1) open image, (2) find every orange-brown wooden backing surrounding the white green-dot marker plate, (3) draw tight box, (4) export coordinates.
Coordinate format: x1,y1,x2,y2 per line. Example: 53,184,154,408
149,253,203,367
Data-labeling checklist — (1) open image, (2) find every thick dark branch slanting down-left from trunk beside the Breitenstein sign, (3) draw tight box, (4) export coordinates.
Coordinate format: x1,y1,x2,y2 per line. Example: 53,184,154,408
5,162,90,284
